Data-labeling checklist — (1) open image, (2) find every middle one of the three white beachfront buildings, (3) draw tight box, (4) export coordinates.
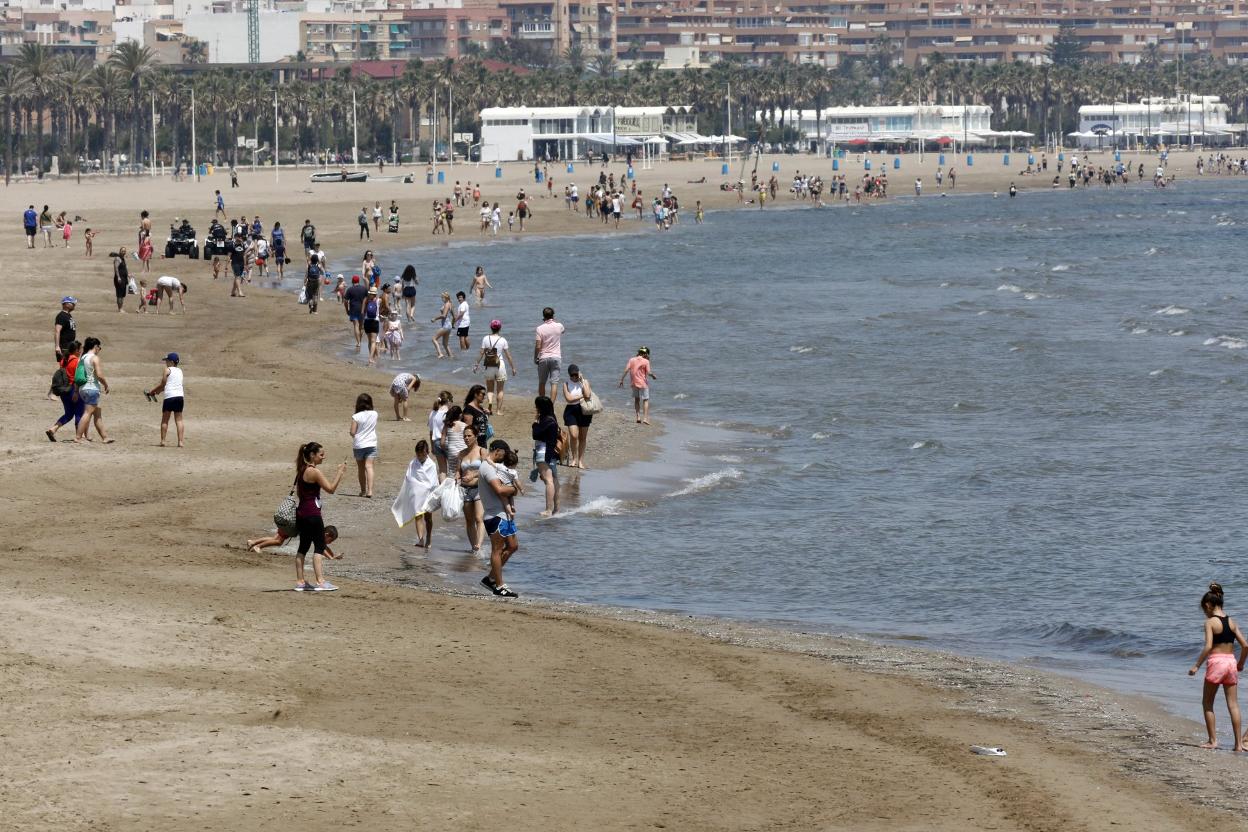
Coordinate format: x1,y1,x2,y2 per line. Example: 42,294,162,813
755,104,993,150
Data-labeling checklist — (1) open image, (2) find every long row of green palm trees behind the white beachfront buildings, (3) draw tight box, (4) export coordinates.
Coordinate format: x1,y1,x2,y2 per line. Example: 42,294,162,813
7,39,1248,181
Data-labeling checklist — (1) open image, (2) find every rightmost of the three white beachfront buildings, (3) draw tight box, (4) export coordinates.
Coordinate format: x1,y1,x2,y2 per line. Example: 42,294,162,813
1071,95,1246,147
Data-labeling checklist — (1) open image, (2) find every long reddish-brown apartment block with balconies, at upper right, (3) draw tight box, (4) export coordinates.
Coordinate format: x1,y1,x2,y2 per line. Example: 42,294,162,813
614,0,1248,66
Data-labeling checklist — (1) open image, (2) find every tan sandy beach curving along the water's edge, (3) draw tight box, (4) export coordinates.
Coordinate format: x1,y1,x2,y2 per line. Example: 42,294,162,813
0,152,1248,831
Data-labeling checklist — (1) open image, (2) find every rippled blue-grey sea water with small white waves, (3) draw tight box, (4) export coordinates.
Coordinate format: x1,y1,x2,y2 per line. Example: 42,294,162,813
364,181,1248,713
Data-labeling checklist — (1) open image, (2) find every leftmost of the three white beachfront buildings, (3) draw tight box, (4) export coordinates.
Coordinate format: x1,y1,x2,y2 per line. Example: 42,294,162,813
480,106,703,161
